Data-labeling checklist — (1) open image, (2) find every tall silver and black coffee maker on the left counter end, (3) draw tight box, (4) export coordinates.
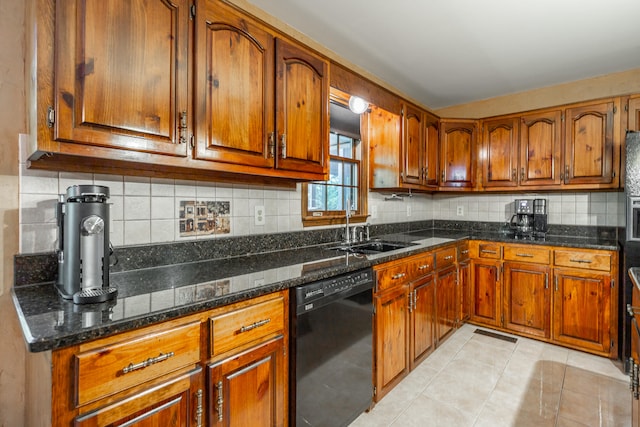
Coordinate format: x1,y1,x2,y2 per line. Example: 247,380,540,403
56,185,117,304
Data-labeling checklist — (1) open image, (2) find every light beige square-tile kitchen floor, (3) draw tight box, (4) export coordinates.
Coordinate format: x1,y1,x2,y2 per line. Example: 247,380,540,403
350,324,631,427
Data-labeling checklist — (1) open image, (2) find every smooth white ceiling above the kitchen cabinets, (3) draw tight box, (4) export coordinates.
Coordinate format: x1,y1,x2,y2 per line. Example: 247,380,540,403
249,0,640,109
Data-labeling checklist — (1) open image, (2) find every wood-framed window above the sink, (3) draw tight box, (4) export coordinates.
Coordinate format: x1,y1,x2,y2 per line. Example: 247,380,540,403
302,89,367,225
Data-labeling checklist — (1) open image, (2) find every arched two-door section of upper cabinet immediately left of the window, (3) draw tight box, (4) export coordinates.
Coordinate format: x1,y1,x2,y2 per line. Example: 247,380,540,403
195,1,329,179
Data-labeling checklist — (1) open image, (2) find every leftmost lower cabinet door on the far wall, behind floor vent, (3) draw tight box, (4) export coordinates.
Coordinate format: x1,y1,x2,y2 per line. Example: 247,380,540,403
471,260,501,326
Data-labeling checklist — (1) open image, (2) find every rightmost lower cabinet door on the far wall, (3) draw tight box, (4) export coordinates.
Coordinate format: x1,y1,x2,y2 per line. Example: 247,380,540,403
552,268,611,354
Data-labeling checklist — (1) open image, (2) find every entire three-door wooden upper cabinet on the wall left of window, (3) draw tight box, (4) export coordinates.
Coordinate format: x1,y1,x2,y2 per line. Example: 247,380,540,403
30,0,329,181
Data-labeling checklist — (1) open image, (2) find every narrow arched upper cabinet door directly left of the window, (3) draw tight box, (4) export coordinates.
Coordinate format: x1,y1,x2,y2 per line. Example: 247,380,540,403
275,39,329,179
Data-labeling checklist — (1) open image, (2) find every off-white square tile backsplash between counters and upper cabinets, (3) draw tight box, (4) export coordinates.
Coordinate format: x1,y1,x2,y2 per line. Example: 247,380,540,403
20,140,625,254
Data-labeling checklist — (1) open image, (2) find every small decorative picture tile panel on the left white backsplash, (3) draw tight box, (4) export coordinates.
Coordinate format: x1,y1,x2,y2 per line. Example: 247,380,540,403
178,200,231,237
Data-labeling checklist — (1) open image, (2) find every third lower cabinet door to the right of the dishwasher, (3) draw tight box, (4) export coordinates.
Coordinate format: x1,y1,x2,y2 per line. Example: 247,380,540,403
436,265,459,342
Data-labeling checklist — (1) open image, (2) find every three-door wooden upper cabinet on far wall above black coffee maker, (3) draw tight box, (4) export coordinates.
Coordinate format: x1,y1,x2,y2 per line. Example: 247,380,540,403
480,99,620,191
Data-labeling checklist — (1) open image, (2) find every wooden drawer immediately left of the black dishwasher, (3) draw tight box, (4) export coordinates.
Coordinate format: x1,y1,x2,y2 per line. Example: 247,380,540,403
209,295,284,357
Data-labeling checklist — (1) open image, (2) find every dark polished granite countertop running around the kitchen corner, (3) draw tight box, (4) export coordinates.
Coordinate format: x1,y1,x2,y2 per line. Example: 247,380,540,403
12,228,618,352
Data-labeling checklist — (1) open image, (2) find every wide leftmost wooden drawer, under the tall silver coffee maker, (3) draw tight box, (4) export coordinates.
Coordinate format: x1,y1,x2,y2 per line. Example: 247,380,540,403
75,321,200,406
